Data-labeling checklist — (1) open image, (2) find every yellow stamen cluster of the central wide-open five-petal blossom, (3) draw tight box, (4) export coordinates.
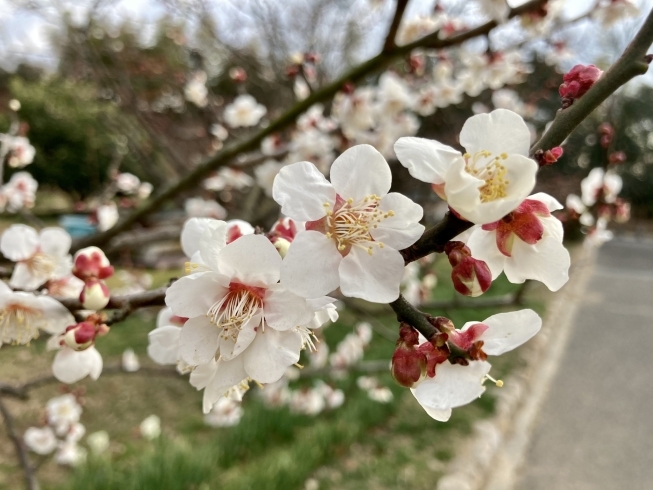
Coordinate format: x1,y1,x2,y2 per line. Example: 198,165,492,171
324,194,395,255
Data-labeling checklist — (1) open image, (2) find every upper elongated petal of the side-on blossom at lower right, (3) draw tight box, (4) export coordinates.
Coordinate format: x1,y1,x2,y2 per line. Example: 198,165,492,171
472,310,542,356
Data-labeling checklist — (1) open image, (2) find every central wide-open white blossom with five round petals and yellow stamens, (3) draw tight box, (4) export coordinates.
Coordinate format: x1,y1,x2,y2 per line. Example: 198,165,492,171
273,145,424,303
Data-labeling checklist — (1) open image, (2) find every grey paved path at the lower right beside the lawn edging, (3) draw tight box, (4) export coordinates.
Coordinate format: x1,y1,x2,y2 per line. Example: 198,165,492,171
516,238,653,490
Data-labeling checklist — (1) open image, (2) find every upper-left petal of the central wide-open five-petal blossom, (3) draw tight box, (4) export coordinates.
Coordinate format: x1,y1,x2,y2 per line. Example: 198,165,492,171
272,162,336,221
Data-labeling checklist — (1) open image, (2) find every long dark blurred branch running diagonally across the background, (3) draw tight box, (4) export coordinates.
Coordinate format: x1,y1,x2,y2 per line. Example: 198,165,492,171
73,0,547,250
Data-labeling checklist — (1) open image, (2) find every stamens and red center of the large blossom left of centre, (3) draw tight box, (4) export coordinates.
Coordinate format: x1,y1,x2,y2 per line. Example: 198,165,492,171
206,283,265,342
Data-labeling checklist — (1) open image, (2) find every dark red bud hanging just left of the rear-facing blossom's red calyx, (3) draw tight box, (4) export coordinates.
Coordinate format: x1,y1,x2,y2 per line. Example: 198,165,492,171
445,242,492,298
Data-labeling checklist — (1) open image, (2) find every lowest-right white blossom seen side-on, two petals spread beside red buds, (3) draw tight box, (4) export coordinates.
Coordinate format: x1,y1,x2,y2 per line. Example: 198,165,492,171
410,309,542,422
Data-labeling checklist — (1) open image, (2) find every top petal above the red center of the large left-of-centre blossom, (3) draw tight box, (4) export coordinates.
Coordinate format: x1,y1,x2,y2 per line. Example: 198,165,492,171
218,235,281,287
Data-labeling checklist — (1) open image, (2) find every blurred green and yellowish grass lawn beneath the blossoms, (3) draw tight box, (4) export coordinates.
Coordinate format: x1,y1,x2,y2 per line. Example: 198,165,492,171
0,260,543,490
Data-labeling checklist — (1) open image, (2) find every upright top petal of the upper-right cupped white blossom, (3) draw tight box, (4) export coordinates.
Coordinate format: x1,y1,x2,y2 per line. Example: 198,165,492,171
460,109,531,156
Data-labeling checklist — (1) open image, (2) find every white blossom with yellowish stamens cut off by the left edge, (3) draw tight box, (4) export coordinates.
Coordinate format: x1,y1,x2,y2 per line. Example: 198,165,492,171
0,281,75,346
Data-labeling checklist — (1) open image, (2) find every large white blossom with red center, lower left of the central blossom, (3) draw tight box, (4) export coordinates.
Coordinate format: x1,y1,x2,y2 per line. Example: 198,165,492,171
166,235,315,413
